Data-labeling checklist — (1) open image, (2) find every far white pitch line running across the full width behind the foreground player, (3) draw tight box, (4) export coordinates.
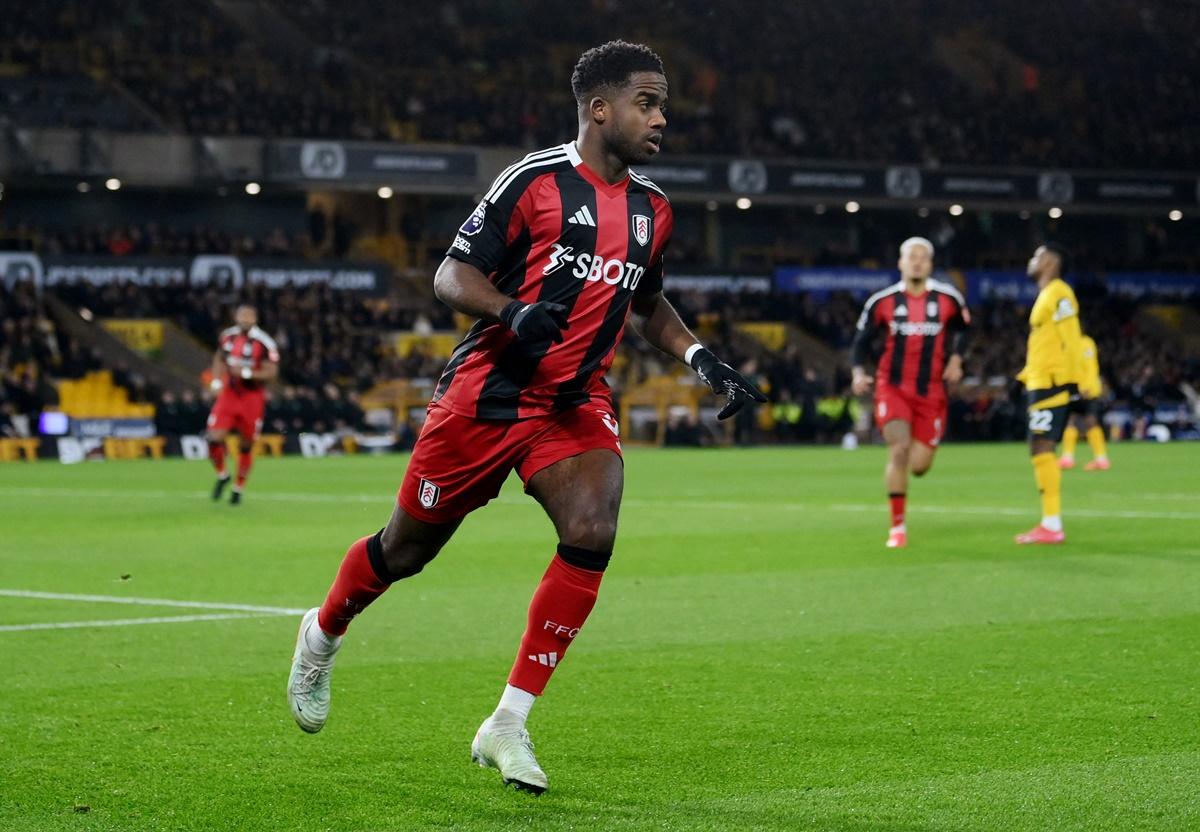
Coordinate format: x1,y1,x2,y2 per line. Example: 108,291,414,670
0,487,1200,520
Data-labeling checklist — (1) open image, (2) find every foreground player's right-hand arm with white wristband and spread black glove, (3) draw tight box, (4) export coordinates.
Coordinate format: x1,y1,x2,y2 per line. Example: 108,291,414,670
632,289,767,419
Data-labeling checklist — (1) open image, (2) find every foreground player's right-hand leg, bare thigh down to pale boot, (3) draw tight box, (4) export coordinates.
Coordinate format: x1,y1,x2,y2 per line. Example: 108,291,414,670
472,444,624,794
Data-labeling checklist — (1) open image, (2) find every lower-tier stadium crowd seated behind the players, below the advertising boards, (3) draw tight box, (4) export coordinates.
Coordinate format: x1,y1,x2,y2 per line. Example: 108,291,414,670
0,268,1200,444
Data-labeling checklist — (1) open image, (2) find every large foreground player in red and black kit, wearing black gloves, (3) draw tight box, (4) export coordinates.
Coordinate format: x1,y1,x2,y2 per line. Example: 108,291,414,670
288,41,766,794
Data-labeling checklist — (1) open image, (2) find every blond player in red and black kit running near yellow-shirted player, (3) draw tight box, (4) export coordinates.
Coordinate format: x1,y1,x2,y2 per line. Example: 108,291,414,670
851,237,971,549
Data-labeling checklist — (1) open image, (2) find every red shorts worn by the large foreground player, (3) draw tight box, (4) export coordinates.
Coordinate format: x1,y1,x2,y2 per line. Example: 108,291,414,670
397,397,620,523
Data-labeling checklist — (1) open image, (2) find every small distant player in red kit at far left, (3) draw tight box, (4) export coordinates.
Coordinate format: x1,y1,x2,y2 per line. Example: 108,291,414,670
205,305,280,505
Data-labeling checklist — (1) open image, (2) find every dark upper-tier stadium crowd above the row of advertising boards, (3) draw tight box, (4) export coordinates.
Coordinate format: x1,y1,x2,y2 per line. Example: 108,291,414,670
0,0,1200,169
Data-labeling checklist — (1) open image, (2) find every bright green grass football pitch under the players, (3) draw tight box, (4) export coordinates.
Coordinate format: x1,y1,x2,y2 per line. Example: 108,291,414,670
0,444,1200,832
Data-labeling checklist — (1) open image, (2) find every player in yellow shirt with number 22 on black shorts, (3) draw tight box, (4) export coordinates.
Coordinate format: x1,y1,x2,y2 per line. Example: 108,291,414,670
1016,243,1082,544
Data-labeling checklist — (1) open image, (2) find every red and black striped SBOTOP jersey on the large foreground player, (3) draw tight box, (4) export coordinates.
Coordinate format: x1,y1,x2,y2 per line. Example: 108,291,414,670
433,142,674,419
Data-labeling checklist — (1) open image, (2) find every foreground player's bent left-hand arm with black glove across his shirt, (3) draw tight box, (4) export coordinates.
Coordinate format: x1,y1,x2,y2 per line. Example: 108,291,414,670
433,257,568,343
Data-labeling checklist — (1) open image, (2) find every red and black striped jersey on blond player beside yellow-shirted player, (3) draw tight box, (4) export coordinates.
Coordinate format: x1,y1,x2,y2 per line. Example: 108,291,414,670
853,280,971,399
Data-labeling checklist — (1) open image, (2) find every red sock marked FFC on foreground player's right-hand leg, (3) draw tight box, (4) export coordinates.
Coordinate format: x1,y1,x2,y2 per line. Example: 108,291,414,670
509,555,604,696
